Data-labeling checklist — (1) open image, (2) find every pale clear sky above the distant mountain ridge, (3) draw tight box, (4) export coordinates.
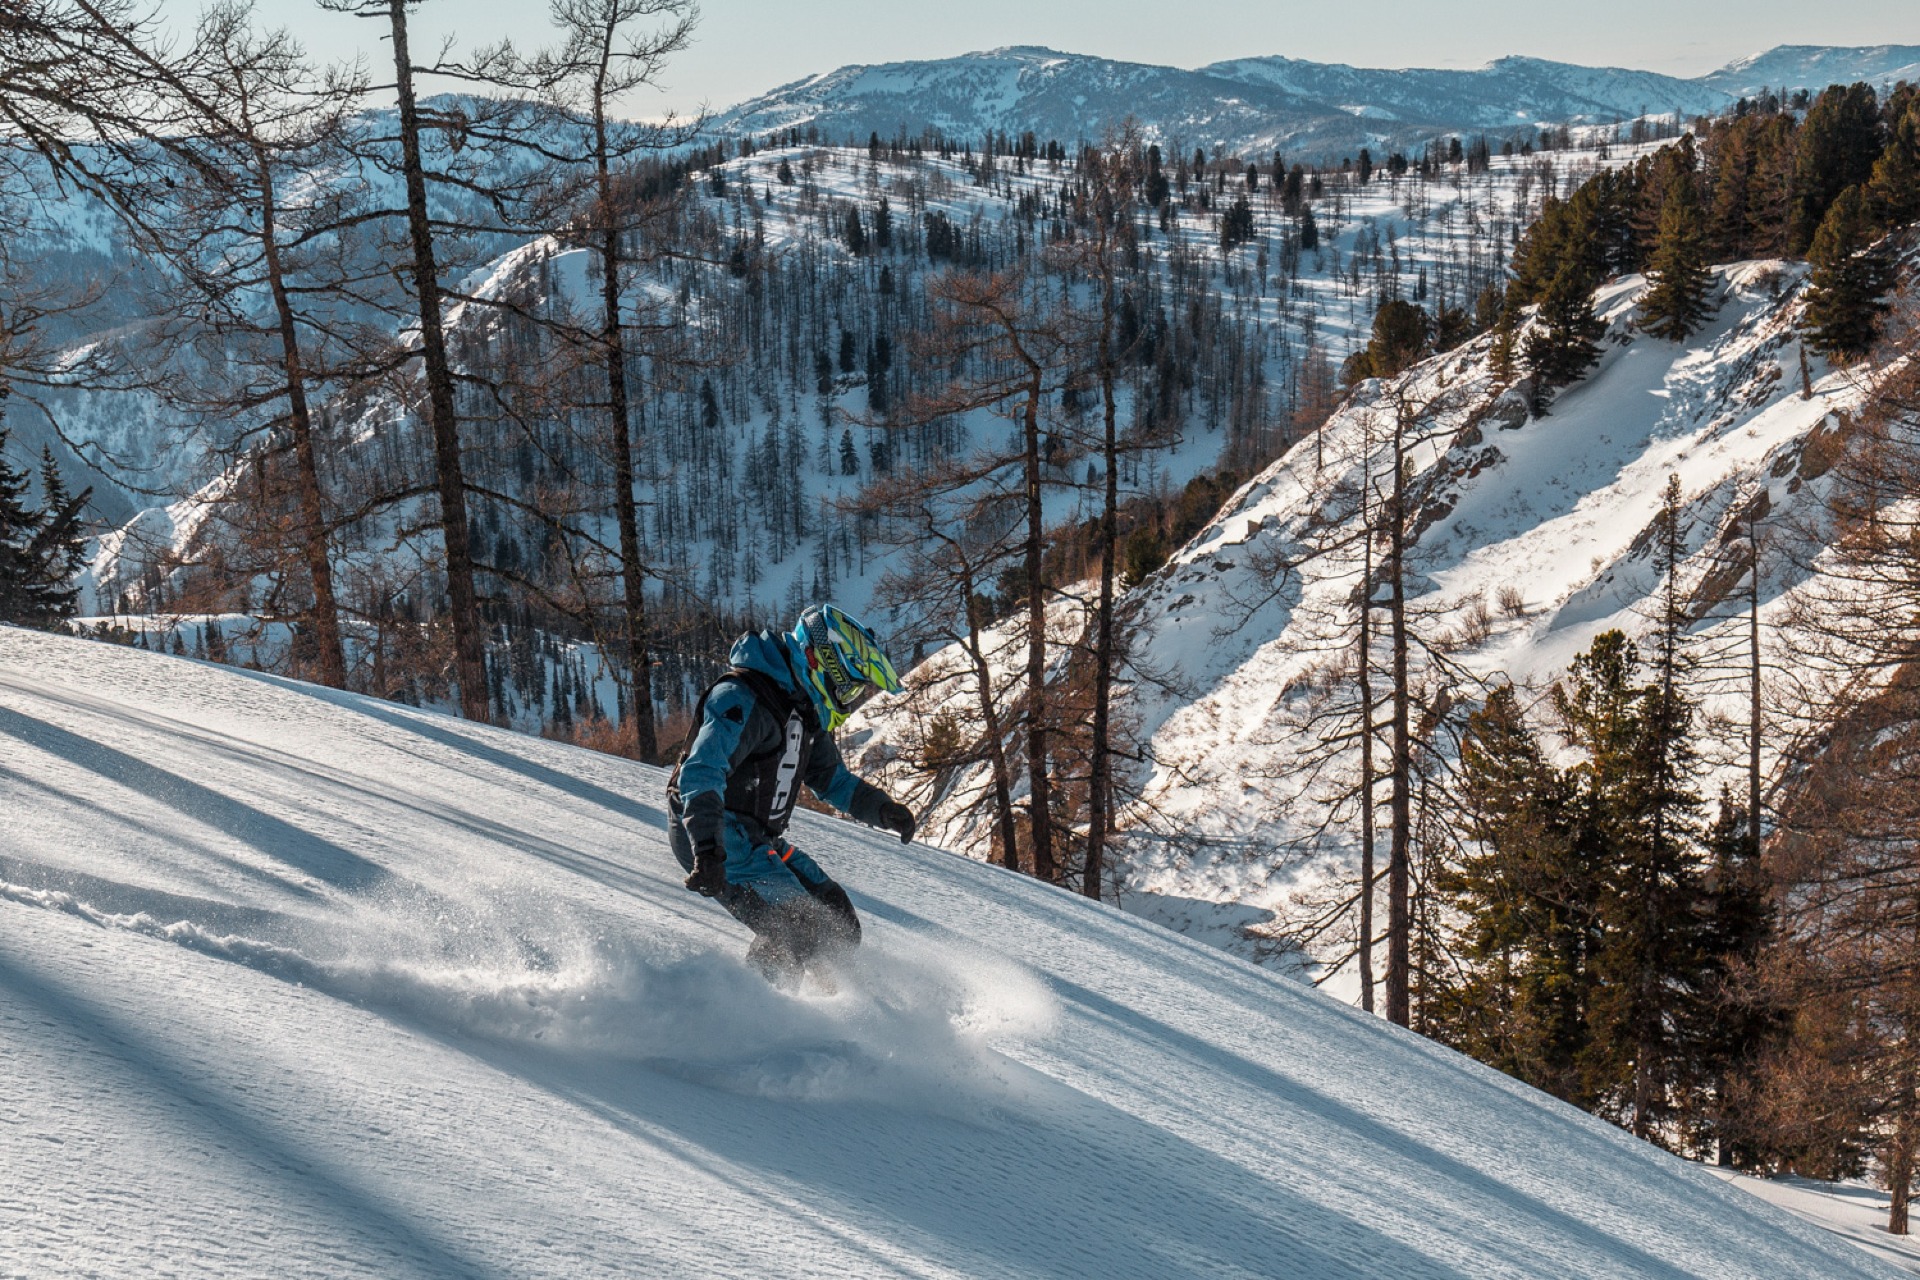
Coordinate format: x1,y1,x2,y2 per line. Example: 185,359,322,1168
159,0,1920,115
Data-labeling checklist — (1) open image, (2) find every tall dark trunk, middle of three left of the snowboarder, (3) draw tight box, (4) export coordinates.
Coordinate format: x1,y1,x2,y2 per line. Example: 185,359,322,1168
388,0,492,720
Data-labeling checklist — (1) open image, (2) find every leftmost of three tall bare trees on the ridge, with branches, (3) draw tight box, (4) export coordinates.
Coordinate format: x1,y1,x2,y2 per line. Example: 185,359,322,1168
135,4,384,689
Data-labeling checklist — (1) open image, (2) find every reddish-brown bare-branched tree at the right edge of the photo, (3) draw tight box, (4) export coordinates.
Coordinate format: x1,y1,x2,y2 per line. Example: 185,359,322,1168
1763,326,1920,1234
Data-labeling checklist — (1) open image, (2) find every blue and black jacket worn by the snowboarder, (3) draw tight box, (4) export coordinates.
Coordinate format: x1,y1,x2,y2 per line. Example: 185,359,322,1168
678,631,887,898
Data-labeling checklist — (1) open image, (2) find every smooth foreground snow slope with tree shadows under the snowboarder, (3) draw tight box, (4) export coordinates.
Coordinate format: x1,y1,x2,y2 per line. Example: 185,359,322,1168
0,629,1893,1280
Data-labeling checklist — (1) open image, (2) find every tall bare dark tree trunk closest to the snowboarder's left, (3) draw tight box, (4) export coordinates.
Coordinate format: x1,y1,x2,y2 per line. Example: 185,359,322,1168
593,102,660,760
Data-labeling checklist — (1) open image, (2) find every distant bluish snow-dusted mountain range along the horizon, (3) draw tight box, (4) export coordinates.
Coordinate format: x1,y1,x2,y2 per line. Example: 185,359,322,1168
712,44,1920,159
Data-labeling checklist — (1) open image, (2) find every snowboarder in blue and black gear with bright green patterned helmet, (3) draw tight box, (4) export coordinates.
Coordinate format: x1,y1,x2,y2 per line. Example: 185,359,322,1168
666,604,916,983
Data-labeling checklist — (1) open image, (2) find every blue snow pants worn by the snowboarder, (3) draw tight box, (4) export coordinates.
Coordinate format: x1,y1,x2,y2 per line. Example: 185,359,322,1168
668,816,860,967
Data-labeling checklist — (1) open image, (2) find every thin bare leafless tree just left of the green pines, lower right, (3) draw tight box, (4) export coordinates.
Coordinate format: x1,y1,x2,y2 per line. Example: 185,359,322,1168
1236,378,1476,1025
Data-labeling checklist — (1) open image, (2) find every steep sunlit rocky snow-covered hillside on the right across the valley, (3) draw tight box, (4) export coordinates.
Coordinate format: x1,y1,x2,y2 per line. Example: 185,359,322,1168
854,239,1914,974
